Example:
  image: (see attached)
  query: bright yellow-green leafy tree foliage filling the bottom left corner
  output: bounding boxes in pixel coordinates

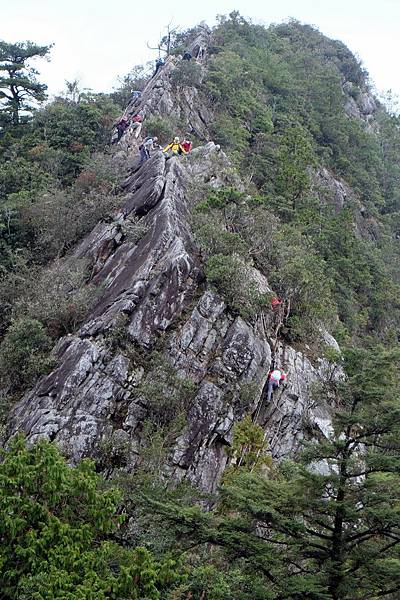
[0,437,184,600]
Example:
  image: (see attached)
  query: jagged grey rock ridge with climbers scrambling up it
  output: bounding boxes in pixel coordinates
[10,25,343,491]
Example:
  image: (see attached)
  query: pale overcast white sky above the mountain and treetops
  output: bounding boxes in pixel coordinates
[0,0,400,102]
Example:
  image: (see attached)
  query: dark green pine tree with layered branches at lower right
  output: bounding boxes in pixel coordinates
[222,349,400,600]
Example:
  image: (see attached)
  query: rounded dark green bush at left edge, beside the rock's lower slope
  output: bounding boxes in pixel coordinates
[0,317,53,391]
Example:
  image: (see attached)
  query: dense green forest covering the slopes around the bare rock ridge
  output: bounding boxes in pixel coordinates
[0,13,400,600]
